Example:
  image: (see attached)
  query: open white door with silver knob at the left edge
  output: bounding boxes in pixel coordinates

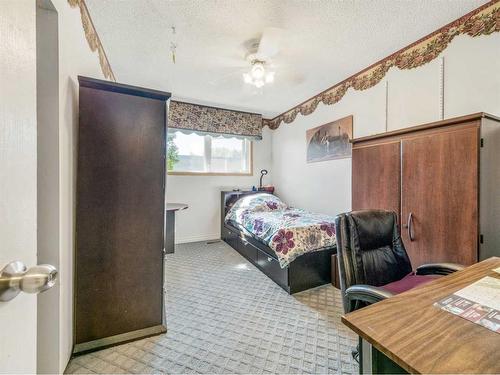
[0,0,57,373]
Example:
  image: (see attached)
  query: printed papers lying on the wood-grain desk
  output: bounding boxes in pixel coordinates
[434,276,500,333]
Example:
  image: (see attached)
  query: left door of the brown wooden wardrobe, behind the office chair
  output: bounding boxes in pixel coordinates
[352,141,401,215]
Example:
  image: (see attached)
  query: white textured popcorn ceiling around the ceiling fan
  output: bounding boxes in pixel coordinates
[86,0,486,117]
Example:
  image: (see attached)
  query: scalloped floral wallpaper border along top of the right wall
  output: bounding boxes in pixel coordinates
[262,0,500,130]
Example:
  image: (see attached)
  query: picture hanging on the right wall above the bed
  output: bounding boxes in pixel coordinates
[306,115,352,163]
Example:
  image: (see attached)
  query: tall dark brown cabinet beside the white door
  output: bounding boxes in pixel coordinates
[74,77,170,353]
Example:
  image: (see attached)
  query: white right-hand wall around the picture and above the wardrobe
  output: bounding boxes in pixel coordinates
[272,33,500,219]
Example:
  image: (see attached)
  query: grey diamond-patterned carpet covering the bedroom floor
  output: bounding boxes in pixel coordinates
[66,242,358,374]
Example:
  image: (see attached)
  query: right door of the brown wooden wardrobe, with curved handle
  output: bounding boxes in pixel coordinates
[401,123,479,267]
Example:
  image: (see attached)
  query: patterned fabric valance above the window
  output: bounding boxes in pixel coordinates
[168,100,262,139]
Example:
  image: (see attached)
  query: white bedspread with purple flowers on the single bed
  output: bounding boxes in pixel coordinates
[226,193,336,268]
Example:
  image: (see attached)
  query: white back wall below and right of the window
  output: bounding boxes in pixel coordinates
[167,128,274,243]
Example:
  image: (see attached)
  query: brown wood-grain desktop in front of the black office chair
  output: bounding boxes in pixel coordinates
[342,257,500,373]
